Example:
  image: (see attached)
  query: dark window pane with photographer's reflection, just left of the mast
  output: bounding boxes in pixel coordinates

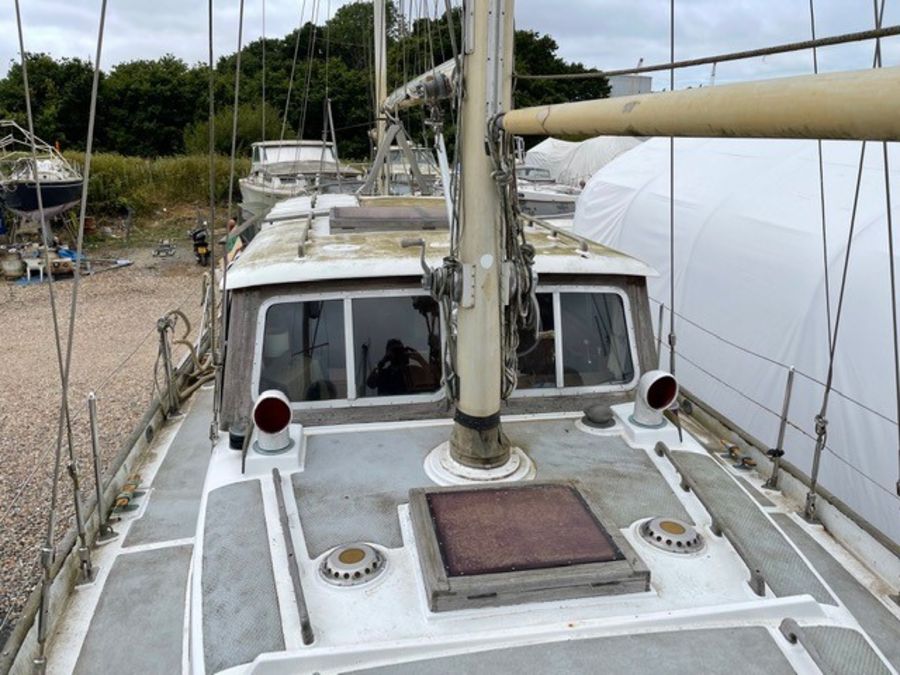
[353,296,441,398]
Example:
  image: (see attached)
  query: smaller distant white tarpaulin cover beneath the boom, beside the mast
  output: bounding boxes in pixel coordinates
[525,136,642,187]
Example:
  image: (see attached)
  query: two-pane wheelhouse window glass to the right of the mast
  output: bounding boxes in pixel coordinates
[518,291,635,390]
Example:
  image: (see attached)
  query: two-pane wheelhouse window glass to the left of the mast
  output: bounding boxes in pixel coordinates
[257,292,441,404]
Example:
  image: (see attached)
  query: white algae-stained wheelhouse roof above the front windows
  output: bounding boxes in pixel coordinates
[228,217,656,289]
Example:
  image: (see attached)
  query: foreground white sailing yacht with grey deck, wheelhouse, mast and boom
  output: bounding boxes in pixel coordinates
[3,0,900,674]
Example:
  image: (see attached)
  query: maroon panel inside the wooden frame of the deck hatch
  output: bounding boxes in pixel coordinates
[426,484,624,577]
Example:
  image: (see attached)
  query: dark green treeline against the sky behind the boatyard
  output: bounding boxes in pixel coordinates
[0,7,609,160]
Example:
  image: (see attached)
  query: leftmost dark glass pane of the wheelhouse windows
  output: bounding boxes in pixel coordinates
[259,300,347,401]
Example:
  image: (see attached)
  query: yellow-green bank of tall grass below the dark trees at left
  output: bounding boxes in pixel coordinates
[65,152,250,215]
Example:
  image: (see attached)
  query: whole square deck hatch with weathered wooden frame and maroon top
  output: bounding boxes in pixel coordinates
[409,482,650,612]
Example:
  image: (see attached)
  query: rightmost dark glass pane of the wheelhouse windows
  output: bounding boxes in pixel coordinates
[560,293,634,387]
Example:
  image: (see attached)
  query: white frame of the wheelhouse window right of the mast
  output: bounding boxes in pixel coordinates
[512,284,641,398]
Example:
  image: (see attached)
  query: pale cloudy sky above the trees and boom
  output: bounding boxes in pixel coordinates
[0,0,900,89]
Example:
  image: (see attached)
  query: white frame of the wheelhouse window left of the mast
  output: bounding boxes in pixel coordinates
[250,288,447,411]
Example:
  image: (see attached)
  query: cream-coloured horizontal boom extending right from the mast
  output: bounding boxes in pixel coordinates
[503,67,900,141]
